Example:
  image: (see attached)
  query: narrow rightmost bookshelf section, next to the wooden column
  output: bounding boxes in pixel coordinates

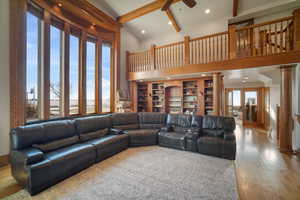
[204,80,213,115]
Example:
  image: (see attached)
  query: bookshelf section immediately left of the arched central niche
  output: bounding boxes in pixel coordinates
[152,83,165,112]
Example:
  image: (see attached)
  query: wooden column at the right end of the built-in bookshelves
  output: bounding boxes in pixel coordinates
[213,72,221,116]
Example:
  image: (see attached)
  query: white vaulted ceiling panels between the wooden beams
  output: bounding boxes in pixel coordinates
[89,0,298,40]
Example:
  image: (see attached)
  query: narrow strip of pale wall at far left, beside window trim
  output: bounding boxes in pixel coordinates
[0,0,10,156]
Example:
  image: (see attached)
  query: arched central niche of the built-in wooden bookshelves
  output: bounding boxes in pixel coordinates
[166,86,182,114]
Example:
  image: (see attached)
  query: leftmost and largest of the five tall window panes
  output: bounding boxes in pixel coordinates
[26,12,41,121]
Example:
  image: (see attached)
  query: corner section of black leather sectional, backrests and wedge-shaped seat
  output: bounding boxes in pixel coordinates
[112,113,166,147]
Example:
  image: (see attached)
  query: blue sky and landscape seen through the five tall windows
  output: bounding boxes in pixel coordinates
[26,12,111,116]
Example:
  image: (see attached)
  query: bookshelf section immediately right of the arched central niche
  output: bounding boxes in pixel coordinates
[182,81,199,114]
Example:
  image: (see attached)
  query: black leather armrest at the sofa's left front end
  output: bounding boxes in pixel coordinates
[11,147,44,166]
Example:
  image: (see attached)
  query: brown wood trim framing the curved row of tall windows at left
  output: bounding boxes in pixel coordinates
[10,0,120,128]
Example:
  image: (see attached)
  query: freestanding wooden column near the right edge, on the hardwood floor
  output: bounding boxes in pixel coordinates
[279,66,293,152]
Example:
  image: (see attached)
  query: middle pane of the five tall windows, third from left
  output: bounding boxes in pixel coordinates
[70,35,79,115]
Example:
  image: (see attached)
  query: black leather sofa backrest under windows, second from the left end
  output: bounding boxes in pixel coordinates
[75,115,112,141]
